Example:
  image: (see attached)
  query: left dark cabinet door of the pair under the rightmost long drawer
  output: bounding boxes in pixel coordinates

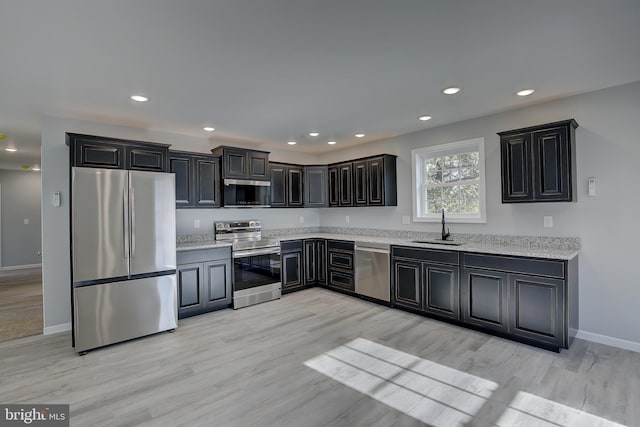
[460,268,509,332]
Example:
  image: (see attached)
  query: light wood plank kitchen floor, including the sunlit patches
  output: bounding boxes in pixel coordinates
[0,288,640,427]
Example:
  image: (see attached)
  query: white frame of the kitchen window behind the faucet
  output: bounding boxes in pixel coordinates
[411,137,487,223]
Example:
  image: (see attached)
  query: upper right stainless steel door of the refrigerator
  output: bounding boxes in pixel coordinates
[129,171,176,275]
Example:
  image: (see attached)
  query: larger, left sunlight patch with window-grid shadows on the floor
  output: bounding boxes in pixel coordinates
[305,338,498,427]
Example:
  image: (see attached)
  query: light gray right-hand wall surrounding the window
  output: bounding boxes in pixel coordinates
[320,82,640,348]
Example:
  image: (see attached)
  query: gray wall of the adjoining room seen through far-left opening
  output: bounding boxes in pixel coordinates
[0,169,42,268]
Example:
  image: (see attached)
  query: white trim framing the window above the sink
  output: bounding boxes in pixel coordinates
[411,137,487,223]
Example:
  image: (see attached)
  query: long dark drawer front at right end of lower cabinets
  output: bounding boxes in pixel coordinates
[463,253,565,279]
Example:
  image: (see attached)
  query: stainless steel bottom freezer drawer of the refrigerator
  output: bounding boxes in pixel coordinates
[73,274,178,352]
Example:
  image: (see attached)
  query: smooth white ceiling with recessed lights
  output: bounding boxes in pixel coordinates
[0,0,640,171]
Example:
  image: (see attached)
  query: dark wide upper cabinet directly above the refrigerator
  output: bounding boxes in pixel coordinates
[67,133,169,172]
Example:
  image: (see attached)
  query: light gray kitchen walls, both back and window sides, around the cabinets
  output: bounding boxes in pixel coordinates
[42,83,640,345]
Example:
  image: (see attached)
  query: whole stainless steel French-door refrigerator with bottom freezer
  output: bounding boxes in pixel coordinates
[71,167,178,353]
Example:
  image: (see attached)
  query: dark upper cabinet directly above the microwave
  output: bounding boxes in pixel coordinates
[211,146,269,181]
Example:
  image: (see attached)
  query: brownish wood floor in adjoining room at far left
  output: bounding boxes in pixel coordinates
[0,268,42,341]
